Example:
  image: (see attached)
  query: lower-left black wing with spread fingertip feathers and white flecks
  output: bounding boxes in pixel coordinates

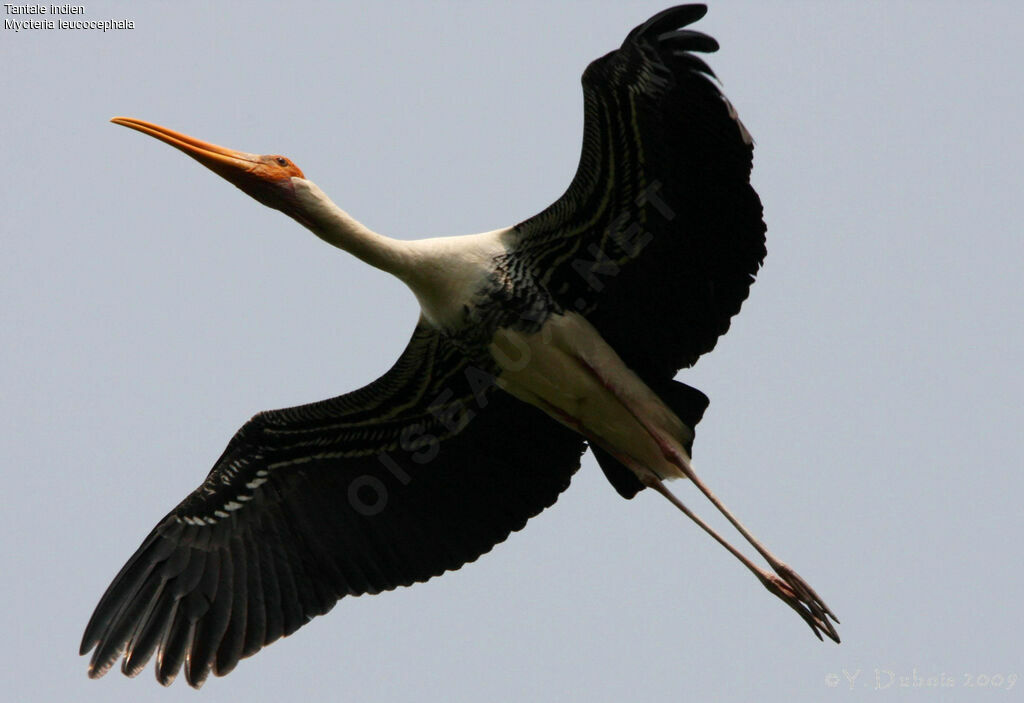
[81,325,584,687]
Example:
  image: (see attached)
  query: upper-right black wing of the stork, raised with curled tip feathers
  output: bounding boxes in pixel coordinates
[509,5,765,382]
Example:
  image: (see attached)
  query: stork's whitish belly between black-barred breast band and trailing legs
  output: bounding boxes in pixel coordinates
[490,312,693,479]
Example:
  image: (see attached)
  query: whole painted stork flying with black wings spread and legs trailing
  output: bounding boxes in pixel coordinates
[81,5,839,687]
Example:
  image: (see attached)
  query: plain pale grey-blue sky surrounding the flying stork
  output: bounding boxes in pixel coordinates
[0,0,1024,703]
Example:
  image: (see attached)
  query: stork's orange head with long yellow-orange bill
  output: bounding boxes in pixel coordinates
[111,118,305,222]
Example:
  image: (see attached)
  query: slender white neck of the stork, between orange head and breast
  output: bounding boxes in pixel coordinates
[292,178,415,279]
